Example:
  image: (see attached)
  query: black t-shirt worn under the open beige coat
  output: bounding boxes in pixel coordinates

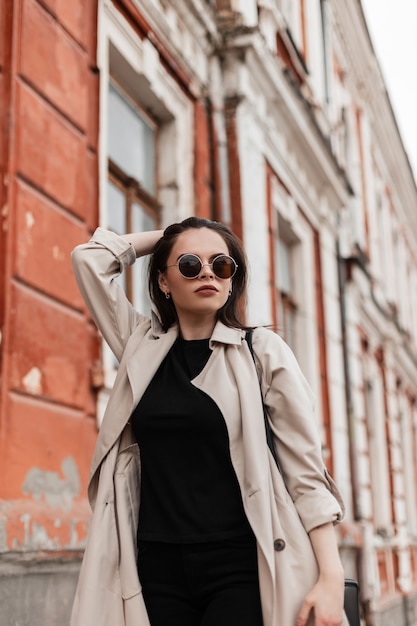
[132,338,250,543]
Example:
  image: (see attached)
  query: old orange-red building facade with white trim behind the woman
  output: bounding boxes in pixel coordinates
[0,0,417,626]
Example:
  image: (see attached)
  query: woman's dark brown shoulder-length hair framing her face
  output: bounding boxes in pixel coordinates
[148,217,247,329]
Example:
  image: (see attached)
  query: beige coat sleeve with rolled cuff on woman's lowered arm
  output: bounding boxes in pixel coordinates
[253,329,344,532]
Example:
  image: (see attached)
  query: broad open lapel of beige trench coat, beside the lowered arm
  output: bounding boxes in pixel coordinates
[192,325,275,581]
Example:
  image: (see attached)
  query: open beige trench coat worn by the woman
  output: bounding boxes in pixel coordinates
[71,228,343,626]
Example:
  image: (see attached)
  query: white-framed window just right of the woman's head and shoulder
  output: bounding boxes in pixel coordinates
[264,164,328,424]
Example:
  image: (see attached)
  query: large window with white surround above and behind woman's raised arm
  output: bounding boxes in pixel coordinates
[97,2,194,424]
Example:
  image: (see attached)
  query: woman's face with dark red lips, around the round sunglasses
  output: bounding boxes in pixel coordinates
[159,228,232,324]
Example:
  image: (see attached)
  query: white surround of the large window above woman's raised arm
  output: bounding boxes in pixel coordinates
[97,0,194,426]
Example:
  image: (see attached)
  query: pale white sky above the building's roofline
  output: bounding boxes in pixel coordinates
[362,0,417,180]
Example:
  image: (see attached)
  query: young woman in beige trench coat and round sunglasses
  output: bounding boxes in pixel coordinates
[72,217,347,626]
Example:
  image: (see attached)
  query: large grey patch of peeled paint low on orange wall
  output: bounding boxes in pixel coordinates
[22,457,80,511]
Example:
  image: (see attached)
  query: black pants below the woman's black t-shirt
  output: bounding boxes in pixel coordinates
[138,537,262,626]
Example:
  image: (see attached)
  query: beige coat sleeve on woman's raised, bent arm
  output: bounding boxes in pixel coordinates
[71,228,146,361]
